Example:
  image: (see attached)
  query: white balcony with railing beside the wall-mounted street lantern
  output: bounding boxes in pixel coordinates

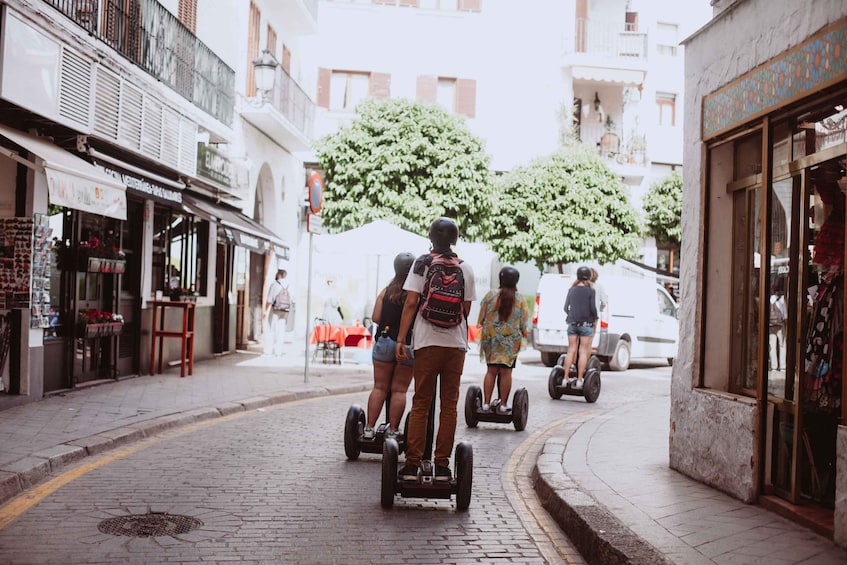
[239,66,315,151]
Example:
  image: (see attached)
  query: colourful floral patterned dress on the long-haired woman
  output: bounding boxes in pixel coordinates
[478,290,529,367]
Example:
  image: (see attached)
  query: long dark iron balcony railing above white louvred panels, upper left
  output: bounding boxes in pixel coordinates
[44,0,235,125]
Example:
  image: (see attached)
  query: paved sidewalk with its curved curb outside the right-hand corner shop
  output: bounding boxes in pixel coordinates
[536,396,847,565]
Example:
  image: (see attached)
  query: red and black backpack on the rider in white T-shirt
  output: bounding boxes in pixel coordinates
[419,253,465,328]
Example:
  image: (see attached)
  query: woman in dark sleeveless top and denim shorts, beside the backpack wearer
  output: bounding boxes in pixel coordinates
[362,253,415,439]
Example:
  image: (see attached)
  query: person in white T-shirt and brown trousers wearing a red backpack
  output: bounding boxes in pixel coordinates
[396,218,476,482]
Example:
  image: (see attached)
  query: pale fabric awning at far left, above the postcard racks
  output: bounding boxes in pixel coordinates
[0,125,126,220]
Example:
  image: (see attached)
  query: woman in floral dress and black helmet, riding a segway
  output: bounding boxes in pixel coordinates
[477,266,529,414]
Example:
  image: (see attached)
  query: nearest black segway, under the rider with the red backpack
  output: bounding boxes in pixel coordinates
[380,396,473,512]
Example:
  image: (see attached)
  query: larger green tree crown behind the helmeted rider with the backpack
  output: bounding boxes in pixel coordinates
[315,99,492,240]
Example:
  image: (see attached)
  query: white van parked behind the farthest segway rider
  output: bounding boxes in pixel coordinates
[532,273,679,371]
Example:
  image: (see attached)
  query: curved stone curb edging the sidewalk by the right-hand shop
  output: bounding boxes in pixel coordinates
[532,431,671,565]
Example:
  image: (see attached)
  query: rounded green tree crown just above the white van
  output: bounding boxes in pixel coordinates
[486,143,639,270]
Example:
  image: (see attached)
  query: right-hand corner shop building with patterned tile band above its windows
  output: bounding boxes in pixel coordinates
[670,0,847,545]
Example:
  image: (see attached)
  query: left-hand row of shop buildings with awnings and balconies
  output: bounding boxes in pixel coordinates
[0,0,317,405]
